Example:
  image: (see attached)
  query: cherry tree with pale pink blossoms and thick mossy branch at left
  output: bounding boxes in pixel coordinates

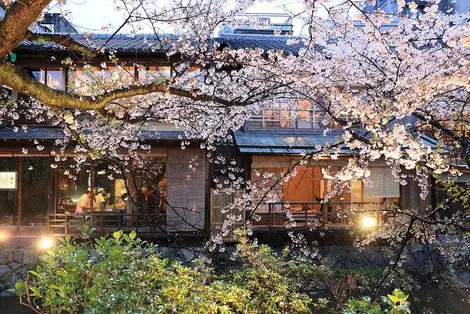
[0,0,470,288]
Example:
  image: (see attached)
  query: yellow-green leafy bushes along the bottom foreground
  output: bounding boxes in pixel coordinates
[15,227,408,314]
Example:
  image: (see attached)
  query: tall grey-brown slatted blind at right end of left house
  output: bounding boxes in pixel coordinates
[166,148,206,231]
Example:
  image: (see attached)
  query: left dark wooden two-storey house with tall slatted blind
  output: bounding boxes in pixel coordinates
[0,16,209,236]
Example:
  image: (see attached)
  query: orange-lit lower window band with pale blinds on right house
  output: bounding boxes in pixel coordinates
[251,156,400,223]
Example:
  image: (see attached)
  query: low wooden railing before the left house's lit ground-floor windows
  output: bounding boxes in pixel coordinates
[47,212,166,236]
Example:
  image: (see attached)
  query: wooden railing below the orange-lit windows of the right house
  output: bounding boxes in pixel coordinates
[252,202,391,228]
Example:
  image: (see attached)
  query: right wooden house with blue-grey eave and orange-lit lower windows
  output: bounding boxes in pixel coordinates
[234,110,436,229]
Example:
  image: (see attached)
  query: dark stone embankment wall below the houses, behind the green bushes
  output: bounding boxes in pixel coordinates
[0,244,470,296]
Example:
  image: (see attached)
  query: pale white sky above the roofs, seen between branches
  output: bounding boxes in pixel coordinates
[51,0,301,33]
